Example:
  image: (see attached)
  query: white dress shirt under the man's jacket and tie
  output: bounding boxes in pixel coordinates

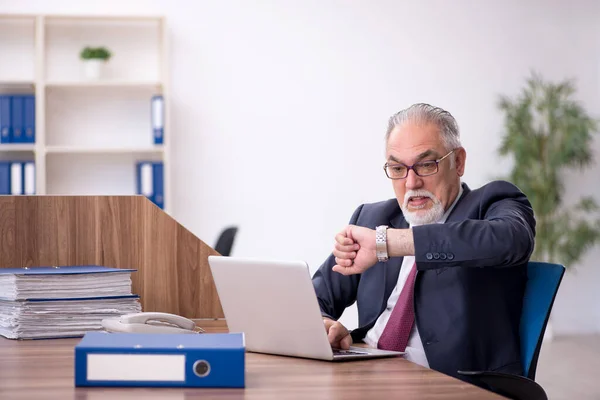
[363,185,463,368]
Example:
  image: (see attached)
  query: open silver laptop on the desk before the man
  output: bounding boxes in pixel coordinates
[208,256,404,361]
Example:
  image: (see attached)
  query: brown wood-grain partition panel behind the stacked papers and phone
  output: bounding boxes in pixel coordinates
[0,195,223,318]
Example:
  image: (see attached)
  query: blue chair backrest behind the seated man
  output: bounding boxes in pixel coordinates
[520,261,565,380]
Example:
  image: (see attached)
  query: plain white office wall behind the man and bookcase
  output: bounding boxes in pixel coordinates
[0,0,600,333]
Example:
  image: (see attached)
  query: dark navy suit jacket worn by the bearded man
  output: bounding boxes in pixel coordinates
[313,181,535,381]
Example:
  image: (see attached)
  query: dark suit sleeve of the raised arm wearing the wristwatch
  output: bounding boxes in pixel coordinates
[413,181,535,270]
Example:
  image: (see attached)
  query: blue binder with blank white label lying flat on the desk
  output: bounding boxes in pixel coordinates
[75,332,246,388]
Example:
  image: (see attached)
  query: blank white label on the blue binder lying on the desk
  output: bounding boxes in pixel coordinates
[87,354,185,382]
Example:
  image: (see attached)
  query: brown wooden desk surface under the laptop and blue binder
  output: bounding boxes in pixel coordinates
[0,320,501,400]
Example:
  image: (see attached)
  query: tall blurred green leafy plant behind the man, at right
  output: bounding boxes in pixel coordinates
[499,73,600,267]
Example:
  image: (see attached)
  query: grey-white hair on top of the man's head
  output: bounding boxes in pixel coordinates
[385,103,461,155]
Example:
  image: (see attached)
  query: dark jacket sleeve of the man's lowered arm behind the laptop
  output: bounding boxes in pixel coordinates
[312,205,363,320]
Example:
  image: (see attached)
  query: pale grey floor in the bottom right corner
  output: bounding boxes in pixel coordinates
[536,335,600,400]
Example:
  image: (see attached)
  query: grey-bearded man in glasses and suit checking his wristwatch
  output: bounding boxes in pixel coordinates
[313,104,535,379]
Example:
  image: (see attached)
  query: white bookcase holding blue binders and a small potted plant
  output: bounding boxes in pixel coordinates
[0,14,172,213]
